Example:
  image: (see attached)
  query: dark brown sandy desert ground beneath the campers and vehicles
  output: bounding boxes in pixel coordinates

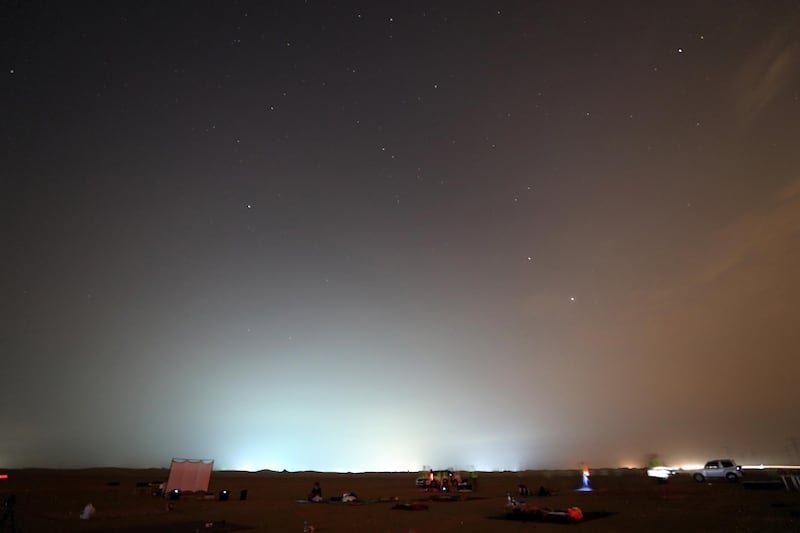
[0,469,800,533]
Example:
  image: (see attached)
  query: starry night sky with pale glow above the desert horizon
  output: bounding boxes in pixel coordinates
[0,0,800,471]
